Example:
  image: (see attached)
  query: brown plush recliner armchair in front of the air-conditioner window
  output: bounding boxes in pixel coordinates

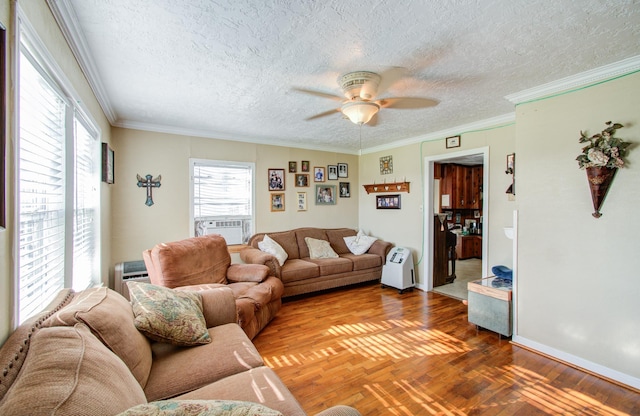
[142,234,284,339]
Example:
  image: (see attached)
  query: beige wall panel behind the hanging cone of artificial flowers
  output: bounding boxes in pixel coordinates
[516,73,640,387]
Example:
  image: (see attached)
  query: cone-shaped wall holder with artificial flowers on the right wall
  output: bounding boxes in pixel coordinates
[576,121,631,218]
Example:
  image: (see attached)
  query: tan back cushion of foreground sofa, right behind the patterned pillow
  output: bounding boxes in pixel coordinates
[42,287,152,387]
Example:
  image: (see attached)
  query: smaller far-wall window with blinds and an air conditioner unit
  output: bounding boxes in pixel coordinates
[189,159,254,245]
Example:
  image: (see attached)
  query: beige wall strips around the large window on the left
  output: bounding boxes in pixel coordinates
[0,1,111,342]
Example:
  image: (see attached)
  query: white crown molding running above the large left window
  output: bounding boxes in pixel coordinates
[47,0,118,125]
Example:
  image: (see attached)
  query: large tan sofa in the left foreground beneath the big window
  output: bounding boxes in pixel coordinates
[0,287,359,416]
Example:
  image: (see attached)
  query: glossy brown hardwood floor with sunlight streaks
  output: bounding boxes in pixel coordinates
[253,284,640,416]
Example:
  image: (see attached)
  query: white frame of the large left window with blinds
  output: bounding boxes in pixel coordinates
[11,3,102,328]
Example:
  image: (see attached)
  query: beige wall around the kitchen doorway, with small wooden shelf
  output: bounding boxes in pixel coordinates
[360,125,515,288]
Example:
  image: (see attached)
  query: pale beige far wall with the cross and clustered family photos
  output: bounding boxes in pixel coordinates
[111,128,359,269]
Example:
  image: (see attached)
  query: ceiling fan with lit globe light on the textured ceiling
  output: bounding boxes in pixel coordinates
[294,67,438,125]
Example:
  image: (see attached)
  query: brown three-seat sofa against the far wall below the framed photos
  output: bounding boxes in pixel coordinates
[240,227,392,297]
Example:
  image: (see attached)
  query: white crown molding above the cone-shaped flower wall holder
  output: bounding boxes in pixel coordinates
[504,55,640,105]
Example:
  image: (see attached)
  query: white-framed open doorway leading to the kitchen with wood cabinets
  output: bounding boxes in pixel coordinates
[423,147,489,299]
